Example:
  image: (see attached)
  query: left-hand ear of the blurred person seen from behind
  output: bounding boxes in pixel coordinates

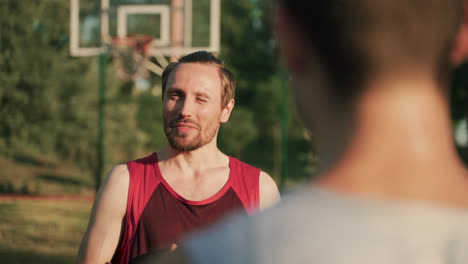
[274,3,309,74]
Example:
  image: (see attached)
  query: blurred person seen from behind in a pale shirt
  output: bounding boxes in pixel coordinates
[137,0,468,264]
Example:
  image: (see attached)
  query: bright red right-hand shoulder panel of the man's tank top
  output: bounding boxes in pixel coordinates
[229,157,260,214]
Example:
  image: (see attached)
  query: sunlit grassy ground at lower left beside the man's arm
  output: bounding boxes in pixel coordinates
[0,154,93,264]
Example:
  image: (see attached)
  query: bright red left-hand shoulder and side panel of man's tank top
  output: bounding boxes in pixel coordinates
[112,153,160,264]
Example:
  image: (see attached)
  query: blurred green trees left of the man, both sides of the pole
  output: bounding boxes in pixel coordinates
[0,0,142,179]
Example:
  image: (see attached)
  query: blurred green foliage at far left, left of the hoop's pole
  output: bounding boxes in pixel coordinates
[0,1,92,159]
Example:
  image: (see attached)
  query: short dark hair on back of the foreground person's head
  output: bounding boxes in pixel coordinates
[280,0,463,100]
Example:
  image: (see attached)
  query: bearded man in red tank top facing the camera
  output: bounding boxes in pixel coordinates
[78,51,279,264]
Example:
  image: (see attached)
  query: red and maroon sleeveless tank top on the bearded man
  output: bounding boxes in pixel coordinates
[112,153,260,264]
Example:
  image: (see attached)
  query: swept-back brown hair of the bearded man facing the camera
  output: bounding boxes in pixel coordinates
[162,51,236,107]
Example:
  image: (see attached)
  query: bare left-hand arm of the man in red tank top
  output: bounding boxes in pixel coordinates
[77,165,129,264]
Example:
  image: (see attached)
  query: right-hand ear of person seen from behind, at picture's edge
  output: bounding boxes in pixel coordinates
[450,0,468,66]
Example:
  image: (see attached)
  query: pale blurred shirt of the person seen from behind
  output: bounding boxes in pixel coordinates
[185,187,468,264]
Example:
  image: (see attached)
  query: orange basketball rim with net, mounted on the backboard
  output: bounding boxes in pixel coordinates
[111,35,153,81]
